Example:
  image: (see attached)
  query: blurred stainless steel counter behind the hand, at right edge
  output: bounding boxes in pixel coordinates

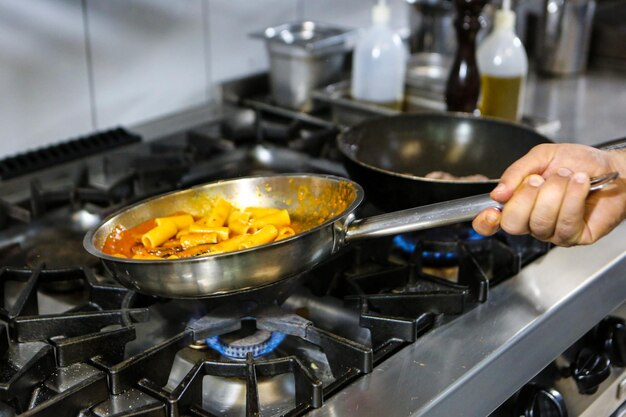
[525,70,626,145]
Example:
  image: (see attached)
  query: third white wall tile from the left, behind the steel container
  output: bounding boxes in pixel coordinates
[208,0,299,83]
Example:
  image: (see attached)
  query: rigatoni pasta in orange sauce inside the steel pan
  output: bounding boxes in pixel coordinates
[103,198,297,260]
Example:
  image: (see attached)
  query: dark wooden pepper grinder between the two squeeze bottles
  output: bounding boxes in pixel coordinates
[446,0,488,113]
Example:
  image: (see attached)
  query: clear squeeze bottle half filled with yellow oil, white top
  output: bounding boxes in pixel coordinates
[477,0,528,121]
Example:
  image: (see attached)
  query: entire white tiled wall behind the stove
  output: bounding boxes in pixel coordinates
[0,0,408,158]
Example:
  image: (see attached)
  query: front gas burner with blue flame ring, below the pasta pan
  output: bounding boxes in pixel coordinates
[206,330,286,359]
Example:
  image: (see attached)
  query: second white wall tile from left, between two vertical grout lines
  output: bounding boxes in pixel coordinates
[87,0,209,128]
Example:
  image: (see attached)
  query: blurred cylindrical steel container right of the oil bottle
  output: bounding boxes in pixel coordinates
[537,0,596,75]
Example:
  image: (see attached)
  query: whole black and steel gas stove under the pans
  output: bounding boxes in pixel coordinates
[0,106,626,417]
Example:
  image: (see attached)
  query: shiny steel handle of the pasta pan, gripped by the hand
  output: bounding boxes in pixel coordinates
[344,172,619,242]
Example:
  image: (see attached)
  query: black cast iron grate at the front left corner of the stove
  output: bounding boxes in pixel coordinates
[0,265,147,416]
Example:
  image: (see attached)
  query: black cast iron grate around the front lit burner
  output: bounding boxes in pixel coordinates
[83,303,372,416]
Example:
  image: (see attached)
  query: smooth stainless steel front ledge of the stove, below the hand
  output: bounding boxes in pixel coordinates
[311,223,626,417]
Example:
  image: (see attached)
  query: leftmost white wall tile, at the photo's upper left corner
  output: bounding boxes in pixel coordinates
[0,0,93,158]
